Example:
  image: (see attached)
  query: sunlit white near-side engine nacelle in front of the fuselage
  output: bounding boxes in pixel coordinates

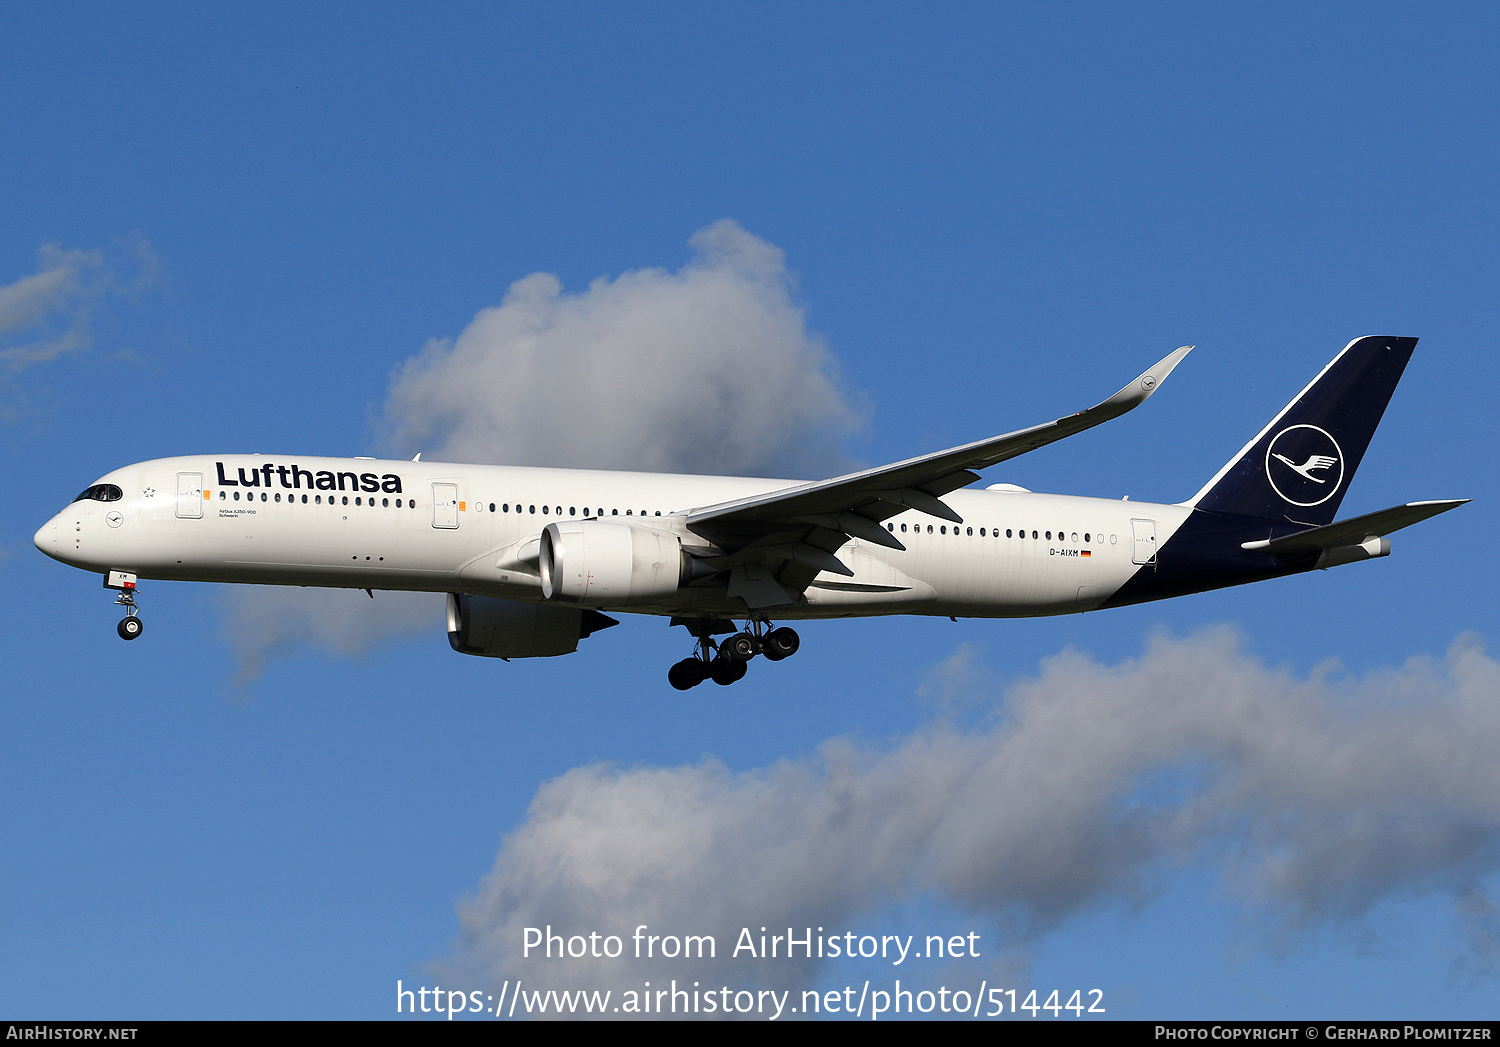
[537,521,693,608]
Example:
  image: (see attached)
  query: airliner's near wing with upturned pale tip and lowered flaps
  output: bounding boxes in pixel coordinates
[687,345,1193,609]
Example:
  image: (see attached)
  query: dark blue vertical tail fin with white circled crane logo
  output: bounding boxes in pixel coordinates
[1187,338,1416,527]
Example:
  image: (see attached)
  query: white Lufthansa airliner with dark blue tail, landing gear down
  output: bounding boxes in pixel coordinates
[36,338,1467,690]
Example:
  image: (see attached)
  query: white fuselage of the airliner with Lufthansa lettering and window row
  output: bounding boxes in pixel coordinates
[36,455,1193,618]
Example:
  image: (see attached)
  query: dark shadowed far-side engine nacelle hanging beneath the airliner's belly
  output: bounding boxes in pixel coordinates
[449,593,620,659]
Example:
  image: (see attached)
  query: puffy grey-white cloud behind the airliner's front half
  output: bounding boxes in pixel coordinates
[228,221,857,680]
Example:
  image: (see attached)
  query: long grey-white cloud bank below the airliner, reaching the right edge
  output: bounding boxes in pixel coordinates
[453,630,1500,989]
